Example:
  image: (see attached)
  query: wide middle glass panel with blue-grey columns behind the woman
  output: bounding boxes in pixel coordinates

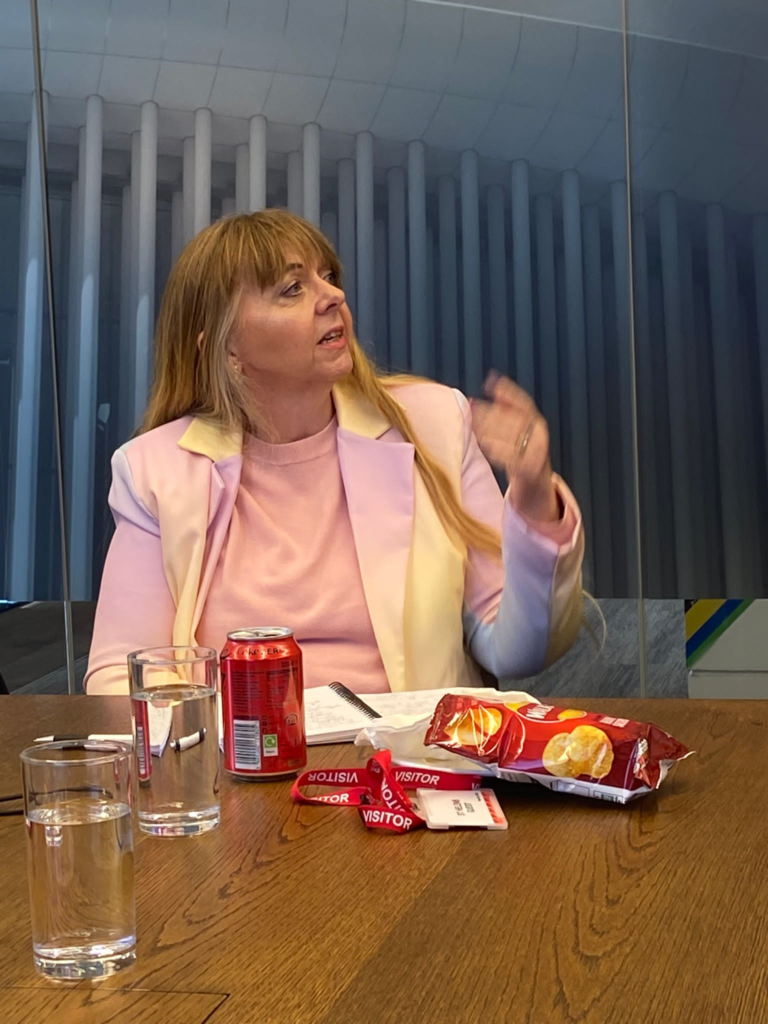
[34,0,639,694]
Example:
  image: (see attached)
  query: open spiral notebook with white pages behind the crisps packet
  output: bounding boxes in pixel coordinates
[304,683,479,744]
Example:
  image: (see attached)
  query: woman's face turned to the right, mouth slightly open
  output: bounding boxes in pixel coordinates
[229,254,352,387]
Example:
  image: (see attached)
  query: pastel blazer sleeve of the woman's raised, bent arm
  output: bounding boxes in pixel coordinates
[457,392,584,679]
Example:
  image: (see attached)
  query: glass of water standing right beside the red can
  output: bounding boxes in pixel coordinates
[128,646,220,836]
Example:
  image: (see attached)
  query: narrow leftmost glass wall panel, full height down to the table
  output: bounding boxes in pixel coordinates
[0,0,68,693]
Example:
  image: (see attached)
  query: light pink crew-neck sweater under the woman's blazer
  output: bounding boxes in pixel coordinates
[198,419,389,693]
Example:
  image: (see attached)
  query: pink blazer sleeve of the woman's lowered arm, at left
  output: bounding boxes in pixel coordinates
[85,446,176,694]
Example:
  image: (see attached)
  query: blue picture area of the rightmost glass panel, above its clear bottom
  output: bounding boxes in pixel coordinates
[629,6,768,598]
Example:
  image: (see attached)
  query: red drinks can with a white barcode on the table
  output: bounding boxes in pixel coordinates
[220,626,306,779]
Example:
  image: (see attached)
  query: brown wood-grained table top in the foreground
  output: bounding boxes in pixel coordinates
[0,696,768,1024]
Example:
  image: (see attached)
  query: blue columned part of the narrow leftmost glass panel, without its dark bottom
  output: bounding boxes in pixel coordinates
[0,4,62,601]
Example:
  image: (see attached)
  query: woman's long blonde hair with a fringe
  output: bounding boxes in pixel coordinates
[140,210,501,557]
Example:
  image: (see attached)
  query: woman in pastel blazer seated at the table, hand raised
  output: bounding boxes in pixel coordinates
[86,210,584,693]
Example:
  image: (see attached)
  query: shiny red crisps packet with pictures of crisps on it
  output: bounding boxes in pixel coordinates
[424,693,691,804]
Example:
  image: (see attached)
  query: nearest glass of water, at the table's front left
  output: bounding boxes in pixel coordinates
[20,740,136,979]
